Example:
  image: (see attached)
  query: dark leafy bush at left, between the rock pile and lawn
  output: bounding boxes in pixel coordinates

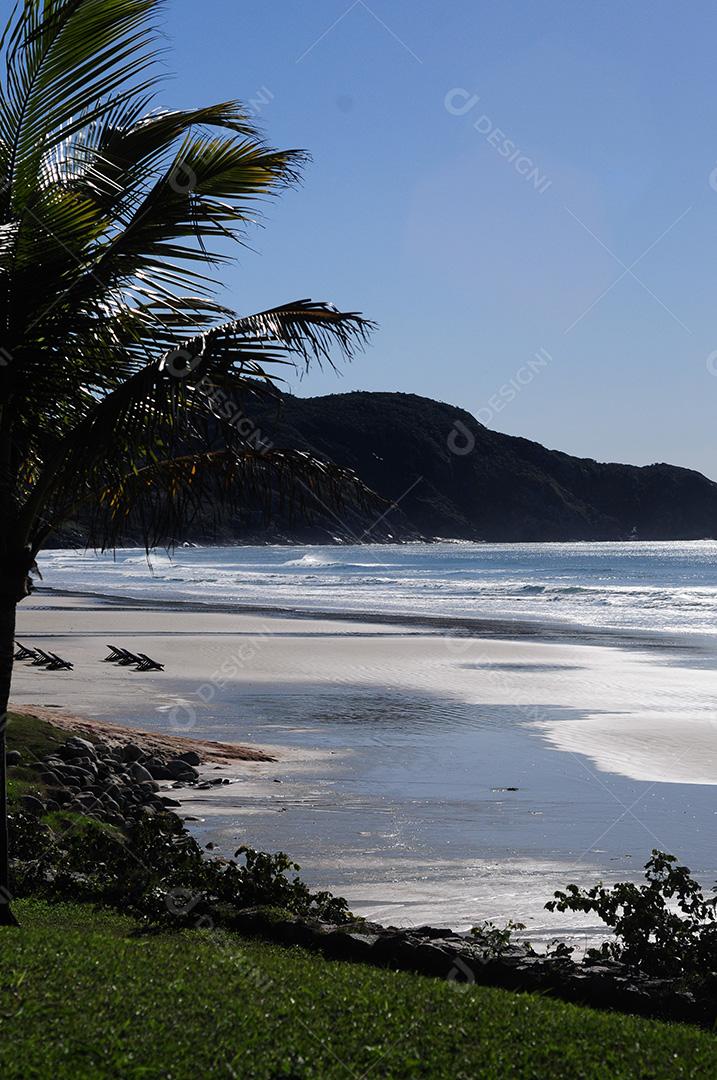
[11,811,351,927]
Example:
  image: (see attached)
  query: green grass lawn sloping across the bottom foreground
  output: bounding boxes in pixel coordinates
[0,901,717,1080]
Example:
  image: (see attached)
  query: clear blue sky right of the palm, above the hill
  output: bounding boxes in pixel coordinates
[168,0,717,478]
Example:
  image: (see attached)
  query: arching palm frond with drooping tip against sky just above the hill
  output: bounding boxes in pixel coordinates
[18,300,373,545]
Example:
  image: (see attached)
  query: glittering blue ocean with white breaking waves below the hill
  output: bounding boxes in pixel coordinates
[40,540,717,635]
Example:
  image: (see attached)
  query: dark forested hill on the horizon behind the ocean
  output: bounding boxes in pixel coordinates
[213,392,717,541]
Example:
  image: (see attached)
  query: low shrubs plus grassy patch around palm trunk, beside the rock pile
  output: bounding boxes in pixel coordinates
[8,713,353,929]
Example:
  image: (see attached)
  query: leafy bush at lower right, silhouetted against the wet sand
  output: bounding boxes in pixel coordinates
[545,850,717,986]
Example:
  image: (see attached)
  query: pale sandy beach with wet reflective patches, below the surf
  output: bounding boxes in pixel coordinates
[13,591,717,940]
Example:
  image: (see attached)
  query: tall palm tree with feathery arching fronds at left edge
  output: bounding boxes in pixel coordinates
[0,0,371,922]
